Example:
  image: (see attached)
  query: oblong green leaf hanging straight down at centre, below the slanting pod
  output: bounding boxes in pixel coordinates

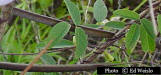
[75,27,88,58]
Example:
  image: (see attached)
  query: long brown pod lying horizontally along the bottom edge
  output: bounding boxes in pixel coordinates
[0,62,140,72]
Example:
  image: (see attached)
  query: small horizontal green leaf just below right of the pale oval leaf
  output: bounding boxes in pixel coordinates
[105,21,125,29]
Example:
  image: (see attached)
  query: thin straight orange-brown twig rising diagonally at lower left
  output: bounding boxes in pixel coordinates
[20,40,53,75]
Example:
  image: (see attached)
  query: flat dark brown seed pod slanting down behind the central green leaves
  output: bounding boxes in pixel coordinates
[12,8,114,38]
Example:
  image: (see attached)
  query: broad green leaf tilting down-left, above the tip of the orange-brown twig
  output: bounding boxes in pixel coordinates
[38,22,71,48]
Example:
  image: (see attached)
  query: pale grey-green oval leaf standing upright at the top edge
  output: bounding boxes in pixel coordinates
[93,0,108,22]
